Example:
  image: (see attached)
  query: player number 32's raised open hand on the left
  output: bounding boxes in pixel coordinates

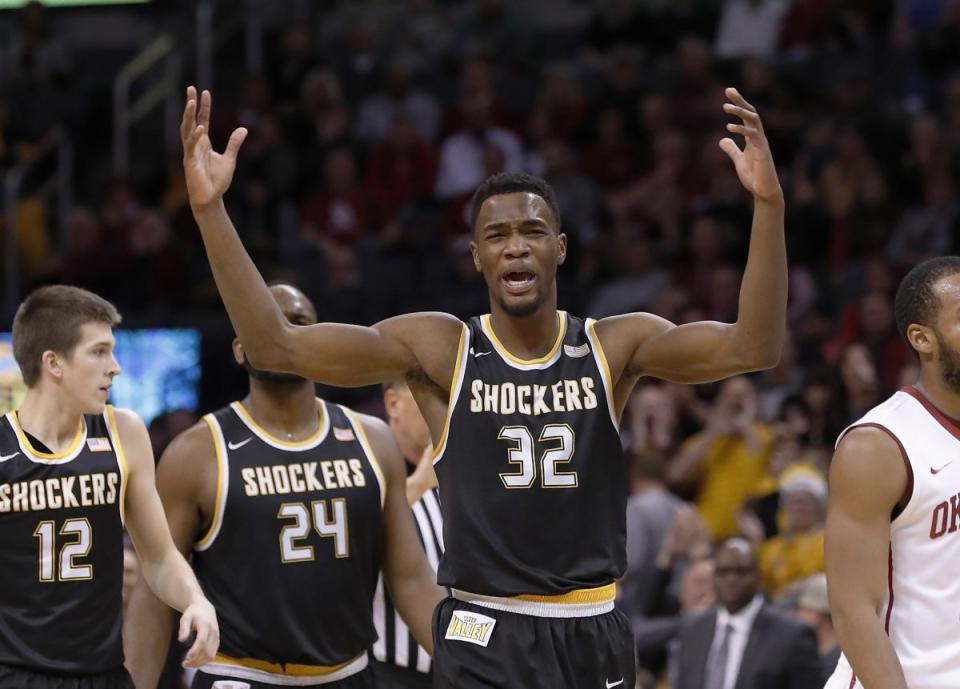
[180,86,247,209]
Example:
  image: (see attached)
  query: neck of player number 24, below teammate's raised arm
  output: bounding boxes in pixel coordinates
[243,380,320,440]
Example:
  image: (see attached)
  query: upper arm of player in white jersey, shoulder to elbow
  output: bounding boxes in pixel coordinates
[826,427,907,615]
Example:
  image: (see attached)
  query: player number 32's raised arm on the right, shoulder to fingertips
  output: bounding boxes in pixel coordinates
[597,88,787,383]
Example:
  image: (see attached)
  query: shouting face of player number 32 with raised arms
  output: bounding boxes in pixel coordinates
[470,192,567,317]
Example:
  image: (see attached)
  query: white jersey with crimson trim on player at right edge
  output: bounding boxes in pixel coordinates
[826,387,960,689]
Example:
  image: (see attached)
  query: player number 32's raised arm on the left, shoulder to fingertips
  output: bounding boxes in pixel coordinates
[180,86,460,387]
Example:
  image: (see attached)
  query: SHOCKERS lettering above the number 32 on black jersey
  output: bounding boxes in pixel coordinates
[470,376,597,416]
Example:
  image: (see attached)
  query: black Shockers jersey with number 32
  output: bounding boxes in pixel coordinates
[436,311,627,596]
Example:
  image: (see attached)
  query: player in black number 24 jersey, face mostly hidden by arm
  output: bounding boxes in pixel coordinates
[127,284,446,689]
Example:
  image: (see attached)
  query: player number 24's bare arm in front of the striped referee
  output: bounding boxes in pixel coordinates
[361,416,446,655]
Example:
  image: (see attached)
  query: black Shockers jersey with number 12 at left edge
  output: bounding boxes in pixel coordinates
[0,406,127,675]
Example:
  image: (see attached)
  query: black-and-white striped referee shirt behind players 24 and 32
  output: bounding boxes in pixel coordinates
[373,488,443,673]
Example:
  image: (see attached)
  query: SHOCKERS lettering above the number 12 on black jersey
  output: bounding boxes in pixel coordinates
[0,471,120,513]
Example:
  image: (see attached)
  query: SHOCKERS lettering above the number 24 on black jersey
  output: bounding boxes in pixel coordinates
[240,459,367,497]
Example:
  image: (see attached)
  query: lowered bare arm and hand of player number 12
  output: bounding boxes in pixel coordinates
[116,409,220,667]
